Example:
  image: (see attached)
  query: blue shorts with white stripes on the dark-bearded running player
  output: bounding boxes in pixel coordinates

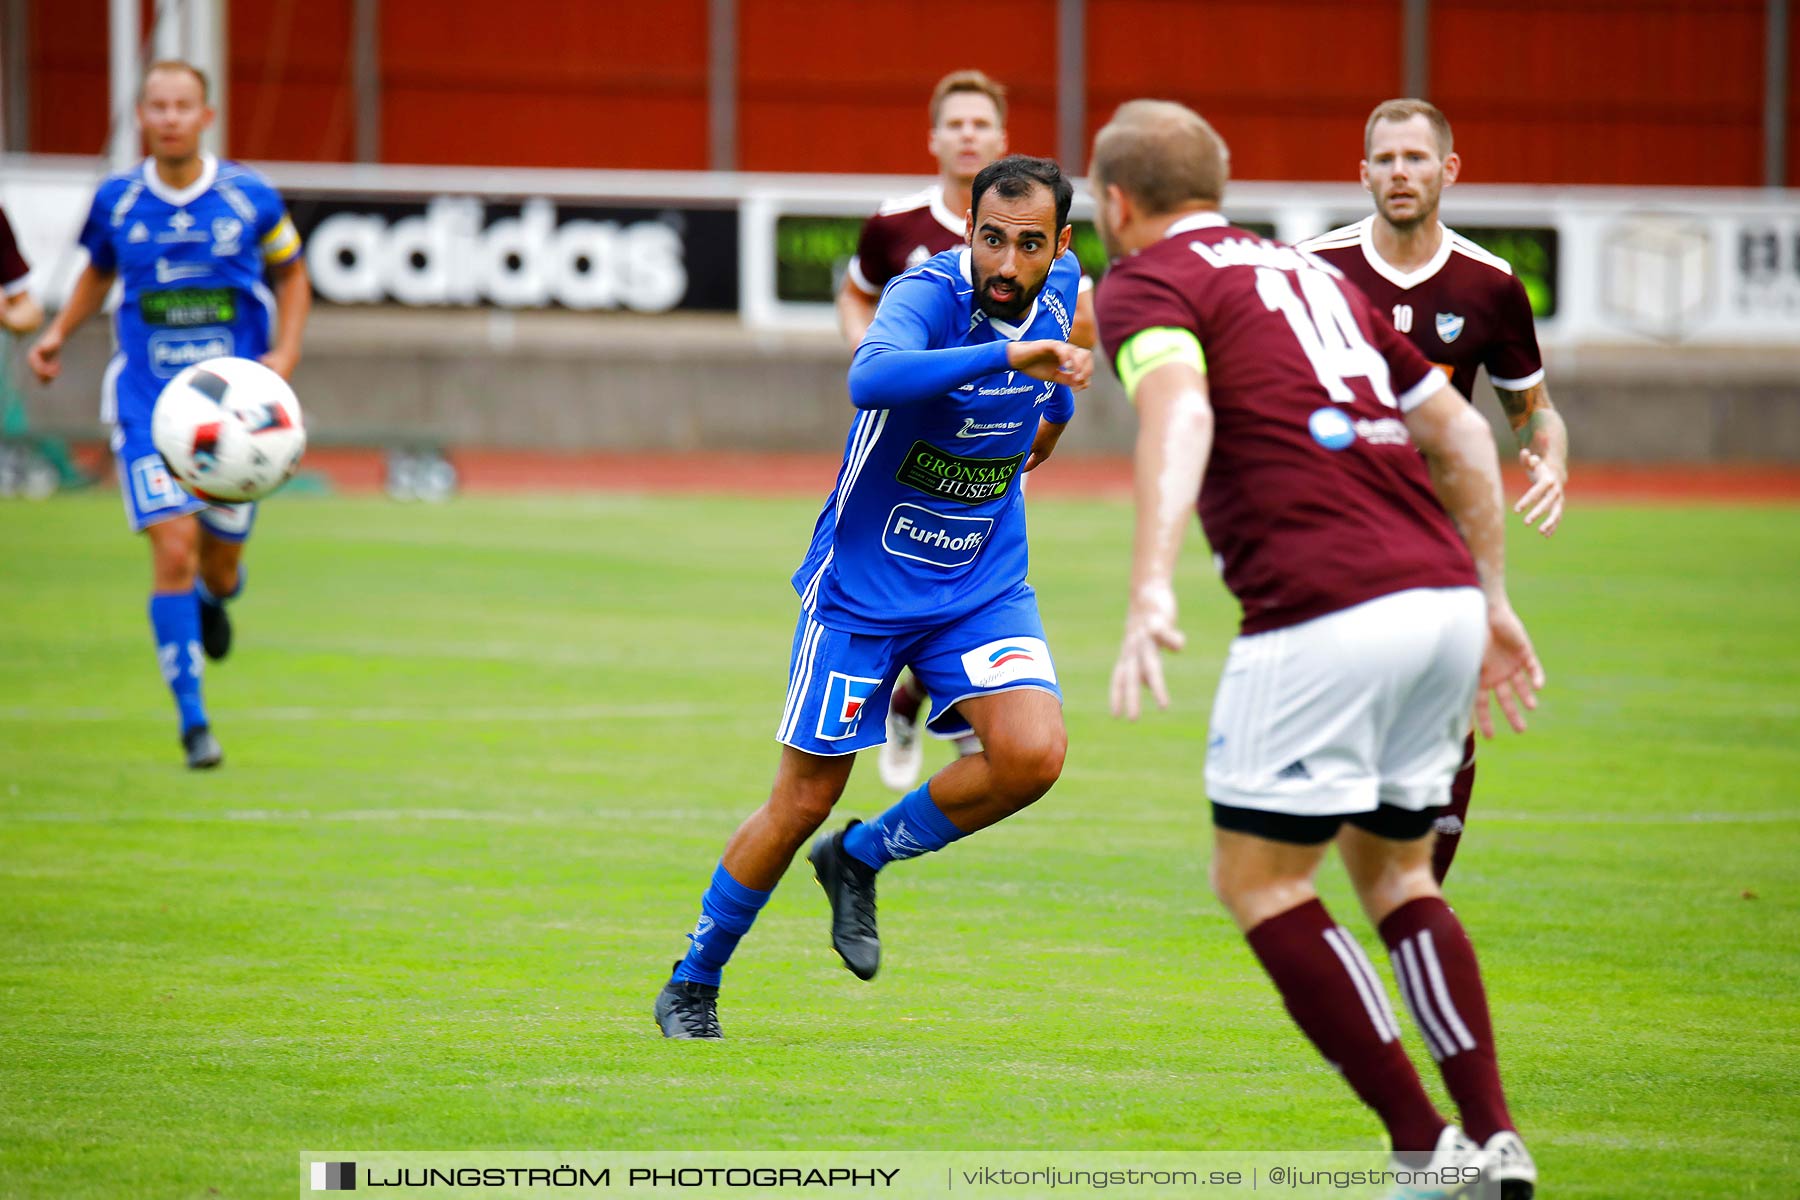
[776,583,1062,754]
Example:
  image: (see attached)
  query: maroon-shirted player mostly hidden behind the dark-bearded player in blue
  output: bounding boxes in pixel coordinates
[837,70,1094,792]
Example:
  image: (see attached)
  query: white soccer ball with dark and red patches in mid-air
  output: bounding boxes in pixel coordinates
[149,358,306,504]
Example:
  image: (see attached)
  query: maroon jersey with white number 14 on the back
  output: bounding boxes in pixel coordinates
[1096,212,1476,633]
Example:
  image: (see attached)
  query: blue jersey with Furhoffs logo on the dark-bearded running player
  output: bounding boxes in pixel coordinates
[794,248,1082,633]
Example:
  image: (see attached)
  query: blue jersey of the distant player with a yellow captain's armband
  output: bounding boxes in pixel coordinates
[81,155,301,423]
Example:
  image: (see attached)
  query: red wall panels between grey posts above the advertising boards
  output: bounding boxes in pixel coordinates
[29,0,1800,187]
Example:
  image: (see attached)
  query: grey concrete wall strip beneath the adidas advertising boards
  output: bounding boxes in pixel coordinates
[14,309,1800,464]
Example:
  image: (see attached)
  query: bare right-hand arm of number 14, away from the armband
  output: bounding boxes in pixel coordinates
[1406,387,1544,738]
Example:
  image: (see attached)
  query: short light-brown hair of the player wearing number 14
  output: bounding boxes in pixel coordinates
[1089,101,1231,212]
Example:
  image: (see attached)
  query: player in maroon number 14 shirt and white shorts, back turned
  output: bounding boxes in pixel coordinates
[1091,101,1543,1200]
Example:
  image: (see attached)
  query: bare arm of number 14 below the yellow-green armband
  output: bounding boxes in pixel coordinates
[1112,362,1213,721]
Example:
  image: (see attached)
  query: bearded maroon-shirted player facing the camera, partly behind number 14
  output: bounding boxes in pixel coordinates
[1300,99,1570,883]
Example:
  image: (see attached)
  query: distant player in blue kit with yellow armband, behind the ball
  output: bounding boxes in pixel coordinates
[31,61,311,768]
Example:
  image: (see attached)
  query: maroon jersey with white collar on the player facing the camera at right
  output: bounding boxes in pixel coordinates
[1300,216,1544,398]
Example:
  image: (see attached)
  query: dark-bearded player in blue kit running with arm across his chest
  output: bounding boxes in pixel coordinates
[655,155,1093,1038]
